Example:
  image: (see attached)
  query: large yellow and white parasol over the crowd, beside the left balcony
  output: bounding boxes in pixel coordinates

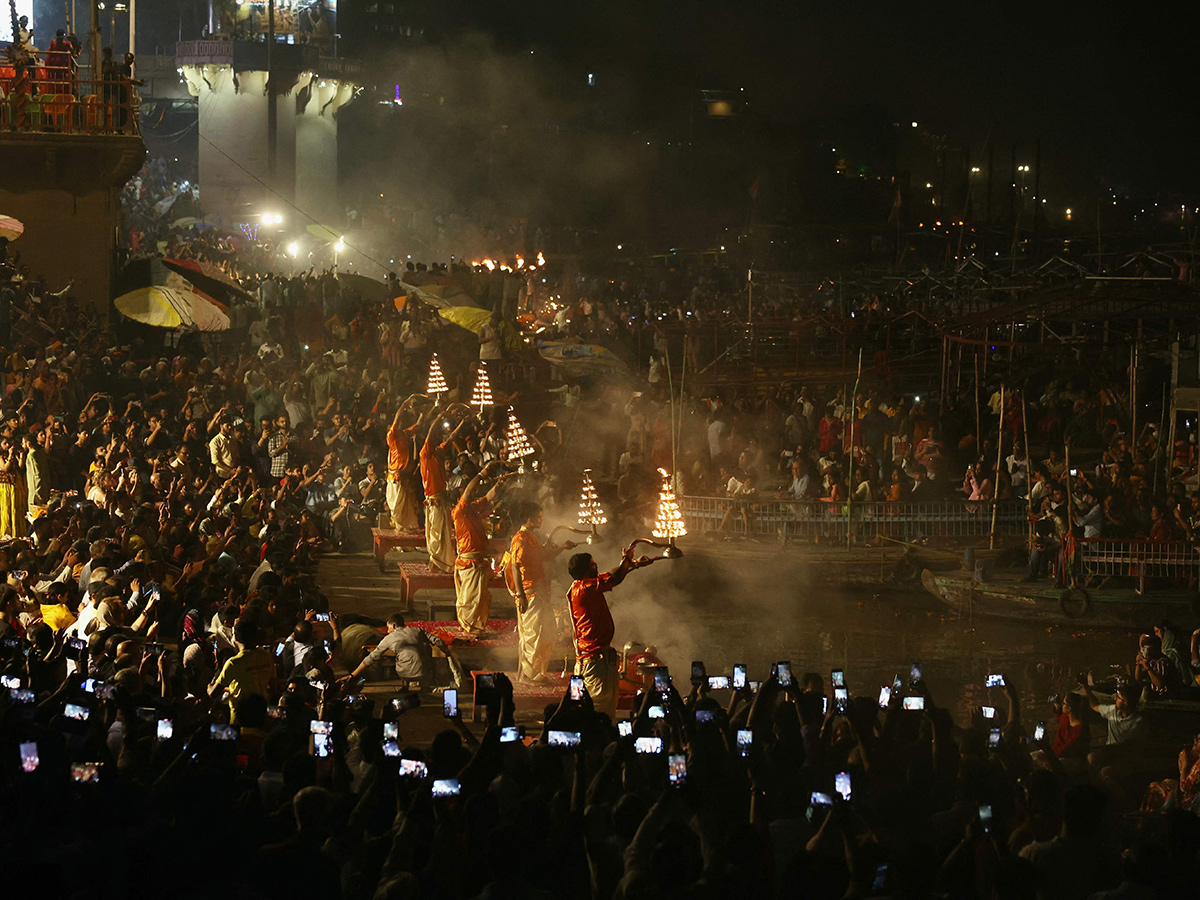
[113,259,229,331]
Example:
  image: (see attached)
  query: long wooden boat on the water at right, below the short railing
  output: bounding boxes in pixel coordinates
[920,569,1198,631]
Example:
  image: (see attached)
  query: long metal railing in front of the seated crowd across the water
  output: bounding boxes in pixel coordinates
[679,494,1028,541]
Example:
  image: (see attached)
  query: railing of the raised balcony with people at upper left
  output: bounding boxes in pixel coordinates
[0,66,138,134]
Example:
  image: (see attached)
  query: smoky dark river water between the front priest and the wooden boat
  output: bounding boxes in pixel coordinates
[610,554,1150,724]
